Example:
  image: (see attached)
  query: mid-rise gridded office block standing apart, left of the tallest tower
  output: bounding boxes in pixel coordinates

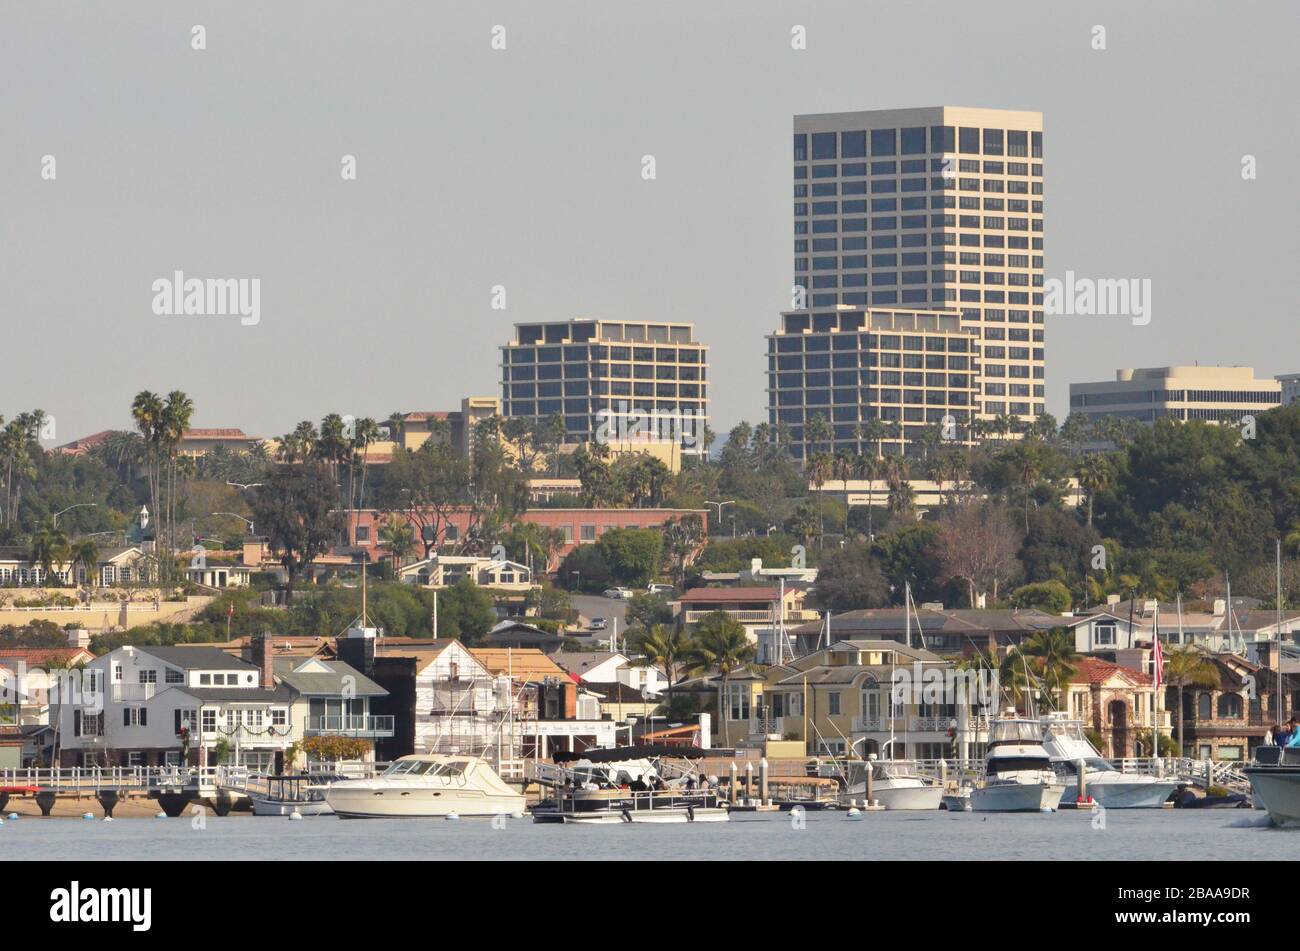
[501,320,709,459]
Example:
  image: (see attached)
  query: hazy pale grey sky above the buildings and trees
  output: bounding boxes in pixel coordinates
[0,0,1300,442]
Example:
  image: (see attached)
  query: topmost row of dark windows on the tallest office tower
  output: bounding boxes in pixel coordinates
[794,126,1043,162]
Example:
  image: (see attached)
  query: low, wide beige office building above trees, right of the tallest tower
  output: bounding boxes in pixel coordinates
[1070,366,1282,424]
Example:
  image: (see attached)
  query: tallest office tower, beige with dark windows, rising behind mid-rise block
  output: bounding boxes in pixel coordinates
[770,107,1044,457]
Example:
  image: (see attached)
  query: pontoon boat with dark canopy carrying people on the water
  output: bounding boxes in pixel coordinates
[533,747,729,825]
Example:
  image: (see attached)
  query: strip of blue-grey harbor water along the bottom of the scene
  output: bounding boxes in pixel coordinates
[0,809,1300,861]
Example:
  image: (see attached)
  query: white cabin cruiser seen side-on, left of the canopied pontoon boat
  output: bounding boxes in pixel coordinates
[325,754,524,818]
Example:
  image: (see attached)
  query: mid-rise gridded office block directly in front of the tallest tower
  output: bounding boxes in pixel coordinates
[767,304,980,456]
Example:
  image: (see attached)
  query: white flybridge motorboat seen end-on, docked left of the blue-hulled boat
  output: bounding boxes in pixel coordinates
[971,718,1065,812]
